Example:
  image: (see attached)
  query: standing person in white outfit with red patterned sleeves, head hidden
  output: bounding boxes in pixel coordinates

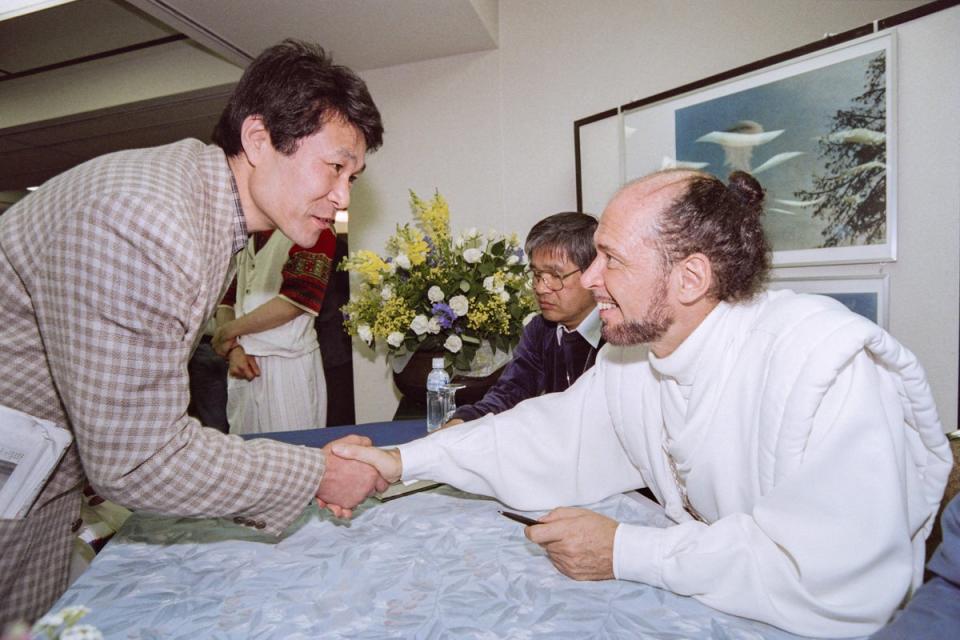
[212,229,336,434]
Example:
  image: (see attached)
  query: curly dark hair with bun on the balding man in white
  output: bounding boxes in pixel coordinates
[657,171,770,302]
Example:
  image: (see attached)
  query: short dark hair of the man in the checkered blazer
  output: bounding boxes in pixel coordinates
[213,39,383,156]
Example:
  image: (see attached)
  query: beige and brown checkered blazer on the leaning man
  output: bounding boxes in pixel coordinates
[0,140,324,627]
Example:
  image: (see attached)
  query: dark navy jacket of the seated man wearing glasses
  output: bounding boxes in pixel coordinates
[453,315,602,421]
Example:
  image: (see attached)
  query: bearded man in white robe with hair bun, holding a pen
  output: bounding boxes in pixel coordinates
[334,171,951,637]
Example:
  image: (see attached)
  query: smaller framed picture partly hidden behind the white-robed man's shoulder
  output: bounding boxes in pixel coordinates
[769,274,890,329]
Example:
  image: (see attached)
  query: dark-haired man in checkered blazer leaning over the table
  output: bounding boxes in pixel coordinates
[0,40,386,628]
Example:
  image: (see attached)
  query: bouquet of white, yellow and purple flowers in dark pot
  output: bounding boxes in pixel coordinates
[341,191,537,371]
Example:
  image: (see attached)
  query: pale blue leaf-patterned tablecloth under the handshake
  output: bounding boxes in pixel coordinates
[52,487,848,640]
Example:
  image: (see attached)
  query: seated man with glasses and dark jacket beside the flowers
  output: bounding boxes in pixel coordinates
[446,212,602,426]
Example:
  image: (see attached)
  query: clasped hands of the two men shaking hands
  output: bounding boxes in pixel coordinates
[317,435,403,518]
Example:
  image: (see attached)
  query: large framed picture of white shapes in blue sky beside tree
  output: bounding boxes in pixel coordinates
[621,31,897,266]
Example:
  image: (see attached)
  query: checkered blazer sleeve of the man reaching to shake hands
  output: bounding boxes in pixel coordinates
[34,195,324,534]
